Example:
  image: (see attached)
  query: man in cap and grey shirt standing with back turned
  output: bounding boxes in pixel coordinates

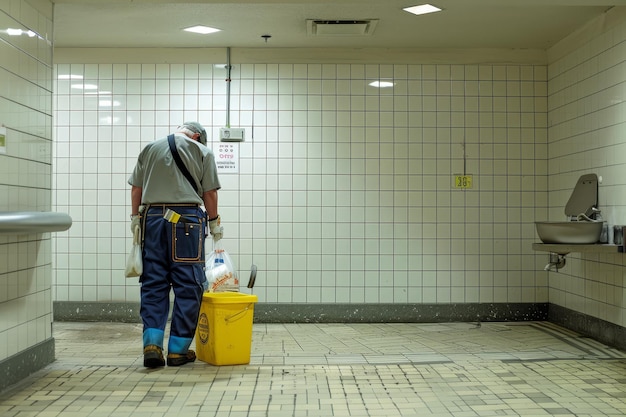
[128,122,223,368]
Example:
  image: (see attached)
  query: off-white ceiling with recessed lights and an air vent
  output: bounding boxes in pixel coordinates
[53,0,626,50]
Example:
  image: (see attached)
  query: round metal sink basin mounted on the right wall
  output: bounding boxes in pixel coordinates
[535,221,604,245]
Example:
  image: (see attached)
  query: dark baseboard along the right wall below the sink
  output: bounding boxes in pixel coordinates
[548,304,626,351]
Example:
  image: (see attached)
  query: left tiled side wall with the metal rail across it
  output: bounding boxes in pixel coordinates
[0,0,54,389]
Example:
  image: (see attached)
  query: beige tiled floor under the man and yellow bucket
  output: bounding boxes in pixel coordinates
[0,322,626,417]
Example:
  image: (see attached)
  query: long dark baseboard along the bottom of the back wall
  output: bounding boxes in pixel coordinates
[54,301,548,323]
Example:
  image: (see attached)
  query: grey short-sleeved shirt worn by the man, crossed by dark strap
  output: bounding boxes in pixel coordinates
[128,134,221,205]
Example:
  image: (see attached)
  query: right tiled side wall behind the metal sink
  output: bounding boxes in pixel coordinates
[548,8,626,327]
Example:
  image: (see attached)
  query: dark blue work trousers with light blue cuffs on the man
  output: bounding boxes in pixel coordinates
[140,204,207,354]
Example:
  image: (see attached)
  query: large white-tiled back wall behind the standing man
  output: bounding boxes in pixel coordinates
[54,55,548,304]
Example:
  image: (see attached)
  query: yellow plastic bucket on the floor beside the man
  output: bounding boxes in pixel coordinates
[196,292,258,365]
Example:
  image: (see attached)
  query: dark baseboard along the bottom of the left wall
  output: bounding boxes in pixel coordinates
[0,338,54,391]
